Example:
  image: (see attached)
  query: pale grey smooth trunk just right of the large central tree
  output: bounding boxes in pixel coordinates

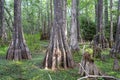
[70,0,79,51]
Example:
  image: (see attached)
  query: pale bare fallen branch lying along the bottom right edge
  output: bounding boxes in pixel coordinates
[77,75,120,80]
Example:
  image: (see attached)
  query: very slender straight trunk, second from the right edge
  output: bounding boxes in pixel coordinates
[110,0,114,47]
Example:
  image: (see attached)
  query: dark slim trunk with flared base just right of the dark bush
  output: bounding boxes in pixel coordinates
[97,0,108,48]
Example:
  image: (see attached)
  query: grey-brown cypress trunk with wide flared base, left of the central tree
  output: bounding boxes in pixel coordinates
[6,0,31,60]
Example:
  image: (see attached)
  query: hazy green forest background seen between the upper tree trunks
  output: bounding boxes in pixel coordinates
[0,0,118,41]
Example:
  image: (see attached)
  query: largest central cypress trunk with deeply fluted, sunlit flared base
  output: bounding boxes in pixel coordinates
[43,0,74,70]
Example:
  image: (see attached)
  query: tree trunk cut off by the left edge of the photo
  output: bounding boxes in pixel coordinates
[0,0,7,41]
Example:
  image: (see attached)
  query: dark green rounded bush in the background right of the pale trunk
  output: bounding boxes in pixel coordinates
[80,16,96,40]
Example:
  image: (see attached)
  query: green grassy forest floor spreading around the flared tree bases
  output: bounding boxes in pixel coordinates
[0,34,120,80]
